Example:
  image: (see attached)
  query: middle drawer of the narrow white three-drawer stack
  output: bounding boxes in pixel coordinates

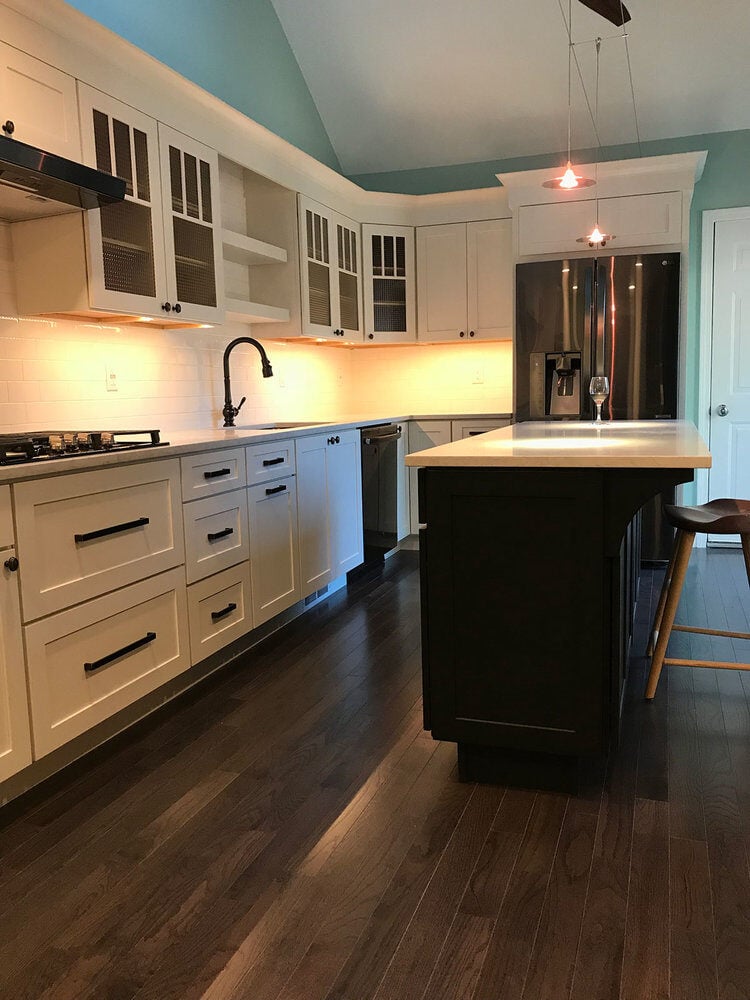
[183,490,249,583]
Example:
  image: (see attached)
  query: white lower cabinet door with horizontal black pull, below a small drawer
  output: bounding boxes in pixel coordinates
[247,476,301,626]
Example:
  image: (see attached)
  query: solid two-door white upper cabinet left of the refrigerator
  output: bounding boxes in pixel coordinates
[417,219,513,341]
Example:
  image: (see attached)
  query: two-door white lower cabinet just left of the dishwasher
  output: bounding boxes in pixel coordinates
[297,430,364,597]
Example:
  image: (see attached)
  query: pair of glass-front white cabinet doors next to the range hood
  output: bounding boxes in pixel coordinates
[79,84,223,323]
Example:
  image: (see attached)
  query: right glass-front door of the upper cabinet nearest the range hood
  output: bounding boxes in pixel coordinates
[159,123,223,323]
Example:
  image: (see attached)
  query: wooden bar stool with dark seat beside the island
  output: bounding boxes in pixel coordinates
[646,499,750,699]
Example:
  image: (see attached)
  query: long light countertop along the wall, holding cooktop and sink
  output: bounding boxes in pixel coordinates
[0,413,511,483]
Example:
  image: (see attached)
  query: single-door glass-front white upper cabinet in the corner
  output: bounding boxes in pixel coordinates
[362,225,417,344]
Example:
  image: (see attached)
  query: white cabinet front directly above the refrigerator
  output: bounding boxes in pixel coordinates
[518,191,682,257]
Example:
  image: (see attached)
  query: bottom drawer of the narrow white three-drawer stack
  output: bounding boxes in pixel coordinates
[188,563,253,663]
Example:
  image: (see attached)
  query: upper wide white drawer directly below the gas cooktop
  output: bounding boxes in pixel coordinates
[13,459,184,621]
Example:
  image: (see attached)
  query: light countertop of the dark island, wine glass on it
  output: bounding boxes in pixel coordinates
[406,420,711,469]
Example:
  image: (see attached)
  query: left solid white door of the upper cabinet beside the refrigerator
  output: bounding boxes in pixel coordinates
[417,222,468,341]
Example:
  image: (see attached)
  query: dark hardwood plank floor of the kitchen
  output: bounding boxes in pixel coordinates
[0,550,750,1000]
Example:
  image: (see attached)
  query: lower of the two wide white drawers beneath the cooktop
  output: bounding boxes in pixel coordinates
[24,568,190,758]
